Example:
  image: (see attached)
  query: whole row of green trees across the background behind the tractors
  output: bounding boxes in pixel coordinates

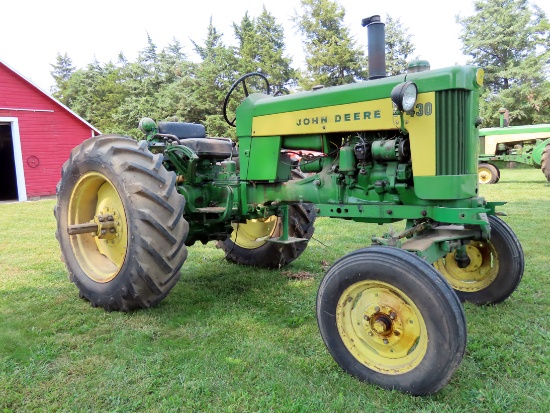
[50,0,550,137]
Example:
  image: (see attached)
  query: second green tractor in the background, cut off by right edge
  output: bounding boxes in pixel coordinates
[478,108,550,184]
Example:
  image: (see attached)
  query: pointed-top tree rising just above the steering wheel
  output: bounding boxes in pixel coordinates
[233,6,297,92]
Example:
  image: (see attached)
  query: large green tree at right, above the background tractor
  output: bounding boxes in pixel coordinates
[456,0,550,126]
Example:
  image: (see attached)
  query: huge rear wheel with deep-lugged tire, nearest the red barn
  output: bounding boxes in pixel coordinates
[54,135,189,311]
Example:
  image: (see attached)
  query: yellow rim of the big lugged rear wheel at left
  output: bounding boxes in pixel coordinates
[68,172,128,283]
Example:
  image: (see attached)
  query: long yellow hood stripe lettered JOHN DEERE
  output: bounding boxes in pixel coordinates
[252,99,396,136]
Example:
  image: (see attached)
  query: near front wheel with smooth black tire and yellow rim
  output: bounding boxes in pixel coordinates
[317,246,466,395]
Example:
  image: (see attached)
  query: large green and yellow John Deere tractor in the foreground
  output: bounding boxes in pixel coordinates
[55,16,524,395]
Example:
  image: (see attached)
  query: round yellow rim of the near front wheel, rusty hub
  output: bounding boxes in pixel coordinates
[336,281,428,374]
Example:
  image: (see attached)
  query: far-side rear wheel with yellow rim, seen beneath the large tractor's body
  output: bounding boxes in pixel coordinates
[217,203,315,268]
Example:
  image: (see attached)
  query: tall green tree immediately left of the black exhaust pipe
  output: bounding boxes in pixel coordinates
[293,0,367,89]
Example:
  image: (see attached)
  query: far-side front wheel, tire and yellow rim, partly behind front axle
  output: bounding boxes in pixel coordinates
[434,215,525,305]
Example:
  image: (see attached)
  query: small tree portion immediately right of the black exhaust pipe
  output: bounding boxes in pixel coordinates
[386,14,415,76]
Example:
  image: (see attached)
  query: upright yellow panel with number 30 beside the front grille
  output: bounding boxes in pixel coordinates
[403,92,437,176]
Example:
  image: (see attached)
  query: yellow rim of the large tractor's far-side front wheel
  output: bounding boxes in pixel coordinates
[434,241,499,292]
